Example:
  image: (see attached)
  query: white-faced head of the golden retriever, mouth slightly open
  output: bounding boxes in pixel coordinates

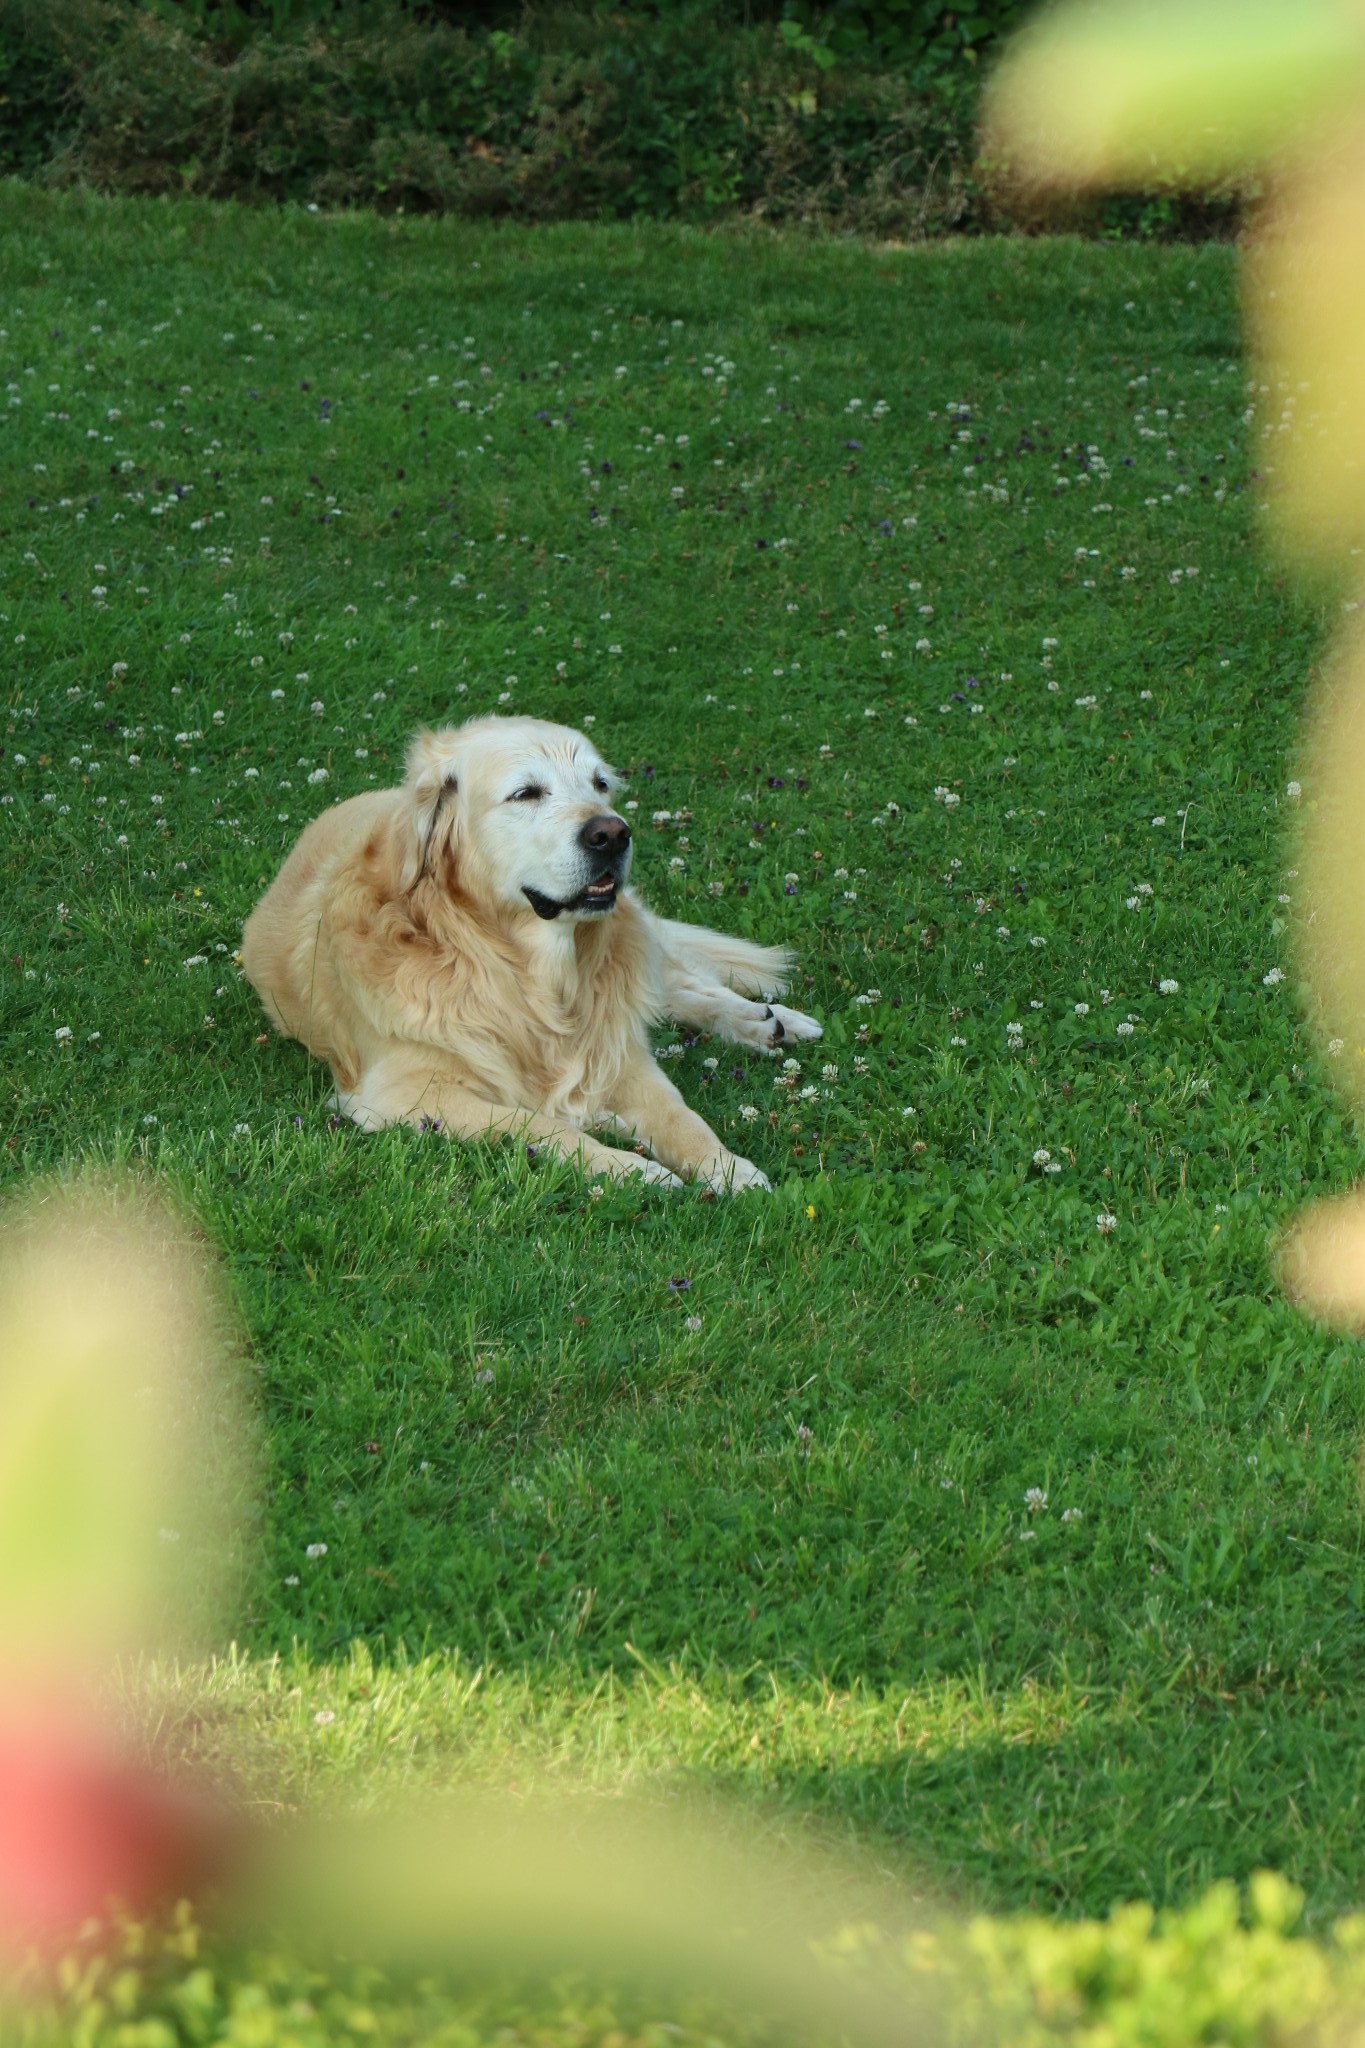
[392,719,630,920]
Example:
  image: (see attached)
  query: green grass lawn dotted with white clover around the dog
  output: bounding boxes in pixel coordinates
[0,184,1365,1974]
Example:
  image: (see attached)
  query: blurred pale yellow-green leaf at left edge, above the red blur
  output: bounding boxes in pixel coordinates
[0,1186,248,1688]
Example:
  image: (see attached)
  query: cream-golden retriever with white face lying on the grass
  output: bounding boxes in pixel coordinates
[241,717,821,1192]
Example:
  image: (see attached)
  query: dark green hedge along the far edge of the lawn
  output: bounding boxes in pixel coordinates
[0,0,1232,238]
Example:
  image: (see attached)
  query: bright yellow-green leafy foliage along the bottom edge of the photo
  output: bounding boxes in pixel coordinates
[15,1874,1365,2048]
